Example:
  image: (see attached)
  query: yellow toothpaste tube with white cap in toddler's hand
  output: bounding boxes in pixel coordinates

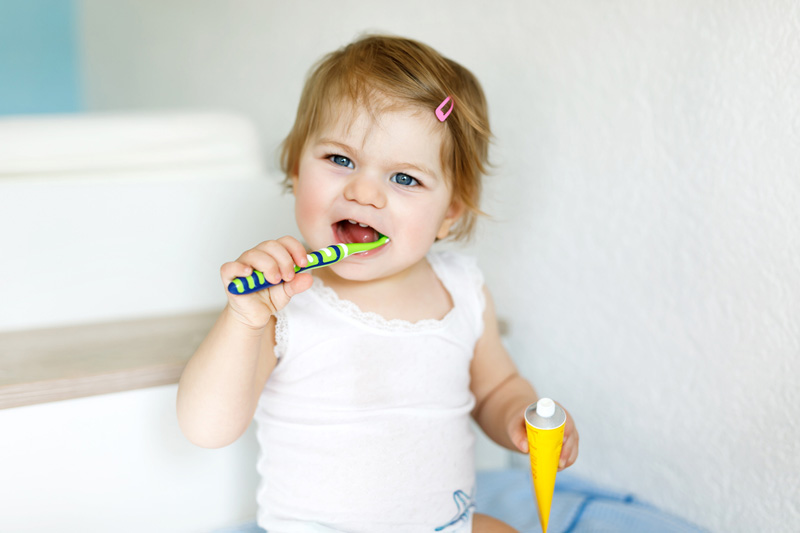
[525,398,567,533]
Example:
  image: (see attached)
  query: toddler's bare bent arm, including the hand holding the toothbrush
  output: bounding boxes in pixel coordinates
[177,237,311,448]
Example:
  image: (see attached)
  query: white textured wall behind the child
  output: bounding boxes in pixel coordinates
[75,0,800,532]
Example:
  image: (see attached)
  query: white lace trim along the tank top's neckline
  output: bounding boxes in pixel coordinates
[310,257,459,330]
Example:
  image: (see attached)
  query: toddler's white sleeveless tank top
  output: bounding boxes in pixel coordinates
[255,252,484,533]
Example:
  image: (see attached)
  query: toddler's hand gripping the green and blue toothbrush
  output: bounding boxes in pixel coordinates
[220,235,312,329]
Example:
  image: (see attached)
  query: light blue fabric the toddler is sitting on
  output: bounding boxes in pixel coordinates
[215,469,706,533]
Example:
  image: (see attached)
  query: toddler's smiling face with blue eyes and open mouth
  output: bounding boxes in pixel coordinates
[292,101,461,281]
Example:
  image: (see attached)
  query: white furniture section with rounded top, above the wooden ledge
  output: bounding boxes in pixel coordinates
[0,111,294,331]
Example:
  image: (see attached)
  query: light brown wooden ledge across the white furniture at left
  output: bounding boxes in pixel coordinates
[0,310,219,409]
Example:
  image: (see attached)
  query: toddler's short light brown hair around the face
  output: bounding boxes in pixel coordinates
[281,35,491,239]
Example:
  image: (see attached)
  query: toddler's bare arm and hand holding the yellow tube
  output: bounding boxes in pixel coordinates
[470,289,578,468]
